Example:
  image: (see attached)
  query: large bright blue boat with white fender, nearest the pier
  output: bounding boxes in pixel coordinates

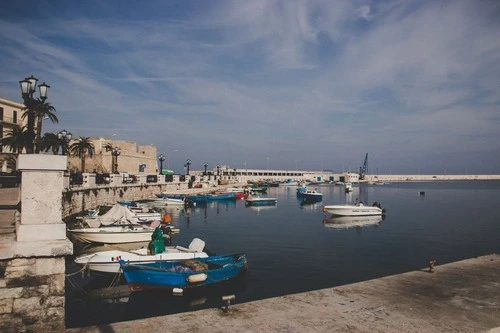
[119,254,247,292]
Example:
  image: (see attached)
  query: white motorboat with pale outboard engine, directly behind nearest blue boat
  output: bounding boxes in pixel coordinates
[75,238,208,273]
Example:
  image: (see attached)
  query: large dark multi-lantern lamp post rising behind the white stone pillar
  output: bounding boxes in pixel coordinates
[19,75,50,154]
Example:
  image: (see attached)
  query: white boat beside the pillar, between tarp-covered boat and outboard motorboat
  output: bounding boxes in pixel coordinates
[68,223,154,244]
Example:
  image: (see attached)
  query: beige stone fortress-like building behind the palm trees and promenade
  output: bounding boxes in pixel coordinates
[68,137,158,174]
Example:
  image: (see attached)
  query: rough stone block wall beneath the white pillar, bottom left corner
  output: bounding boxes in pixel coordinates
[0,257,65,332]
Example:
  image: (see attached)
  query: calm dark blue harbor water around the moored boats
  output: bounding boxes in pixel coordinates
[66,181,500,327]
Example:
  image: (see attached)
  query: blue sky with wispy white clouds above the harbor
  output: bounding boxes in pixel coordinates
[0,0,500,174]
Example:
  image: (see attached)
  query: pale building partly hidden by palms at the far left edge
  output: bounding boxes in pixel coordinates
[0,98,28,172]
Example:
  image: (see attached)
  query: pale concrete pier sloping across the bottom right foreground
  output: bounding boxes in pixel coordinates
[66,254,500,333]
